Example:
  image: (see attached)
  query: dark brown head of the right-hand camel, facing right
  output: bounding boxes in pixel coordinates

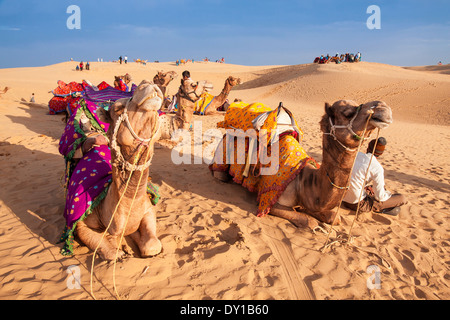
[320,100,393,150]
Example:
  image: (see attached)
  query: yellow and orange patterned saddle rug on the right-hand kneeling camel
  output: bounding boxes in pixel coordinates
[209,102,319,216]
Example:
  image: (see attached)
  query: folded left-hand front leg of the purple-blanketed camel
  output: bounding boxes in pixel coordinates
[76,214,125,261]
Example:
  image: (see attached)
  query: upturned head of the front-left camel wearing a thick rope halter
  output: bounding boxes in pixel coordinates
[97,80,163,169]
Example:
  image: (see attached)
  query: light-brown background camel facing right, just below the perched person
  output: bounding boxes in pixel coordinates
[160,79,213,139]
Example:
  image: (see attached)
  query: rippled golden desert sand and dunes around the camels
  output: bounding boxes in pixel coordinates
[0,62,450,300]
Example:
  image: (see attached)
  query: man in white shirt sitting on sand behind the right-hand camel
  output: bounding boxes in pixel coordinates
[343,137,408,216]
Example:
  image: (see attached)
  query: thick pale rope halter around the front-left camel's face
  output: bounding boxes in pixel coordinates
[111,92,160,171]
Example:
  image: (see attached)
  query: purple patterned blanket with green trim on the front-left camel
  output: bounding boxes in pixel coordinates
[59,99,112,255]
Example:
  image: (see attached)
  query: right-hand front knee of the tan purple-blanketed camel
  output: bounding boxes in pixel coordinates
[131,209,162,257]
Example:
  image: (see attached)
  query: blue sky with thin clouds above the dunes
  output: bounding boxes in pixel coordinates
[0,0,450,68]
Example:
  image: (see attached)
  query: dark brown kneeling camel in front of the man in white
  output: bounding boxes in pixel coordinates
[213,100,392,229]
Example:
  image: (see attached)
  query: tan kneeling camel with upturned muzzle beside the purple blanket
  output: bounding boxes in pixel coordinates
[76,80,163,260]
